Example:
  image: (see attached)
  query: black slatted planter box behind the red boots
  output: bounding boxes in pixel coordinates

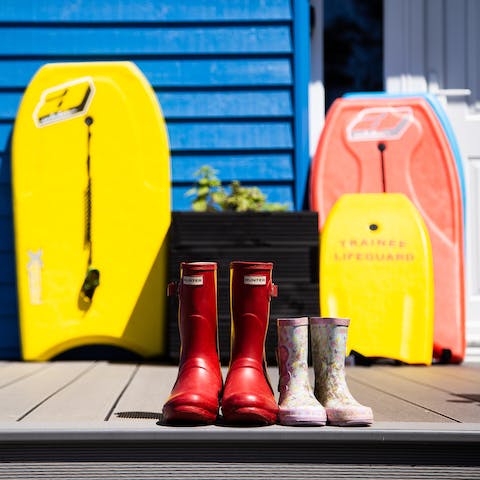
[167,212,320,364]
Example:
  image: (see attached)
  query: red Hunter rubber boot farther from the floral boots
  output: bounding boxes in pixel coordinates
[163,262,222,424]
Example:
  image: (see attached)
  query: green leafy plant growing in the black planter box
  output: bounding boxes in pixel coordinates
[186,165,288,212]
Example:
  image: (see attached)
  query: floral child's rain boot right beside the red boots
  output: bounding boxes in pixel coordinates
[277,317,327,426]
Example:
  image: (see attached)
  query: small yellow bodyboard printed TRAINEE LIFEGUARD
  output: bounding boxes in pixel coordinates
[320,193,434,365]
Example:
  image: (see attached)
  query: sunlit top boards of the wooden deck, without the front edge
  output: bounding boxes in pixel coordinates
[0,361,480,435]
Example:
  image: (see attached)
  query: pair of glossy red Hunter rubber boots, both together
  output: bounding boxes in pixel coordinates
[163,262,278,425]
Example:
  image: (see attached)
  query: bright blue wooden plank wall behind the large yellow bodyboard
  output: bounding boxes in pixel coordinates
[0,0,309,358]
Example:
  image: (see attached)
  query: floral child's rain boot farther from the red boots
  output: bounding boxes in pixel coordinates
[310,317,373,426]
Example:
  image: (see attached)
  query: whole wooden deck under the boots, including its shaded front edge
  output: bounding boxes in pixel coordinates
[0,361,480,479]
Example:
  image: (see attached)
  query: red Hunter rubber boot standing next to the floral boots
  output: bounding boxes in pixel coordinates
[222,262,278,425]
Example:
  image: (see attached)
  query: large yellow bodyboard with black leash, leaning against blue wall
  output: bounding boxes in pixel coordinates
[12,62,171,360]
